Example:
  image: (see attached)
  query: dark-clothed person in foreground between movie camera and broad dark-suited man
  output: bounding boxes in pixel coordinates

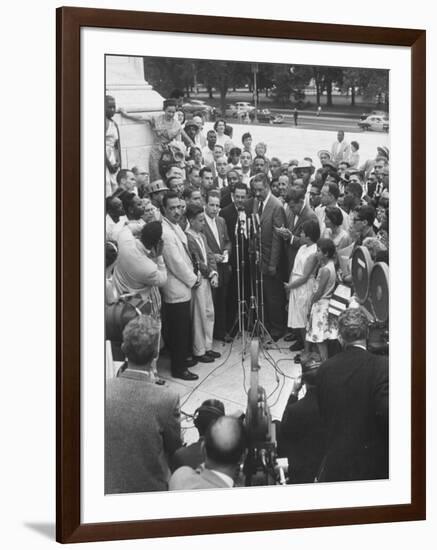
[278,353,325,484]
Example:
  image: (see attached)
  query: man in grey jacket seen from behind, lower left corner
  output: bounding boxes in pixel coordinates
[105,316,182,494]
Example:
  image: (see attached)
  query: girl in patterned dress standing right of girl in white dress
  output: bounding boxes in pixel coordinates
[306,239,337,361]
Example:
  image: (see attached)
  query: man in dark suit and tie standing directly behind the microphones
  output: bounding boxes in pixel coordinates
[220,183,249,333]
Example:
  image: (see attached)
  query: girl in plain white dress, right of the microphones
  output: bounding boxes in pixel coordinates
[284,220,320,351]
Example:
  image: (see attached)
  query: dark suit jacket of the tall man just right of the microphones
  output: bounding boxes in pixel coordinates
[246,193,285,274]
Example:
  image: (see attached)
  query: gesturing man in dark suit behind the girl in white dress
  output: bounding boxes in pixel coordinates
[276,185,317,281]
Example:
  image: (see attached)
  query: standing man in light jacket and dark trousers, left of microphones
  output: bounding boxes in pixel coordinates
[162,192,200,380]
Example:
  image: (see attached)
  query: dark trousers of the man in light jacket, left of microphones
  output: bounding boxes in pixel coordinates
[164,300,191,375]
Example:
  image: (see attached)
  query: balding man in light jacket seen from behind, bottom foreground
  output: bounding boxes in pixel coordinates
[169,416,246,491]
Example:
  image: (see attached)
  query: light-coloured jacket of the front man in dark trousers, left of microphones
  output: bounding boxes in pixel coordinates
[162,218,196,303]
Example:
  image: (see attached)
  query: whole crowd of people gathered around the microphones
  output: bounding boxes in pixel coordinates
[106,96,389,493]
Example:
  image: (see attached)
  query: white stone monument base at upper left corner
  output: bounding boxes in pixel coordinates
[106,55,164,169]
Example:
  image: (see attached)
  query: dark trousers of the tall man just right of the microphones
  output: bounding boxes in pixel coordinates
[263,275,285,338]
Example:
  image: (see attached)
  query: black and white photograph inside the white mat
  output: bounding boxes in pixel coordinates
[101,52,390,495]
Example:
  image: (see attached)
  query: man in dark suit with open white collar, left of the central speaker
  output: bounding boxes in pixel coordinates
[203,190,231,340]
